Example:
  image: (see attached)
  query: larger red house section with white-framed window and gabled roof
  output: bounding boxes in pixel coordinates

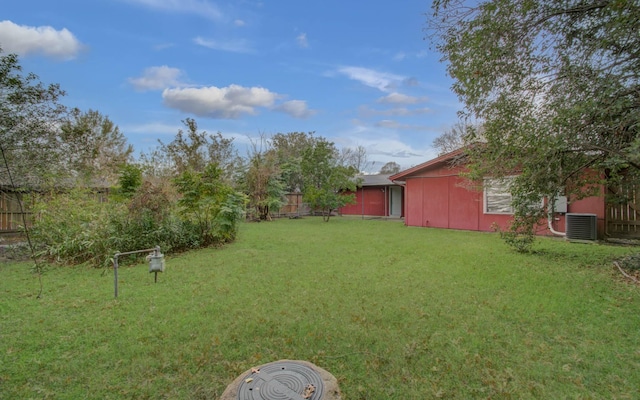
[389,149,611,238]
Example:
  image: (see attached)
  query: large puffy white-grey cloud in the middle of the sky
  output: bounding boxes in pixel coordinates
[162,85,279,119]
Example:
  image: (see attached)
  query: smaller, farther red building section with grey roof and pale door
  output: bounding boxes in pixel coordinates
[338,175,404,218]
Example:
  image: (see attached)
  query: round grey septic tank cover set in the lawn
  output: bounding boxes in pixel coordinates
[221,360,341,400]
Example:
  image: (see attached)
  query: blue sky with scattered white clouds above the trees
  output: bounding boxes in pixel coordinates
[0,0,462,172]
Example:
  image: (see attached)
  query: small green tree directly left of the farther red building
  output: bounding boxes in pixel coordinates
[301,138,358,222]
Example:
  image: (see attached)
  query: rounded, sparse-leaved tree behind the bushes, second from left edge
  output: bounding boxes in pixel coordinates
[61,108,133,186]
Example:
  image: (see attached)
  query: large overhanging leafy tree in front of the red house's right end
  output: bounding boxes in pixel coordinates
[429,0,640,245]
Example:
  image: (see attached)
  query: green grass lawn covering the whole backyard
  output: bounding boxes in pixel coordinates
[0,218,640,400]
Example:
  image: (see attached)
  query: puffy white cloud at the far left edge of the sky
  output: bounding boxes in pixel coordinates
[0,21,83,60]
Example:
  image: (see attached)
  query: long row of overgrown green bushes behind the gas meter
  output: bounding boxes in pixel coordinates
[32,173,245,267]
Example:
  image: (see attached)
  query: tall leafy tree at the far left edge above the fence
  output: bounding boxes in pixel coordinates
[0,49,66,186]
